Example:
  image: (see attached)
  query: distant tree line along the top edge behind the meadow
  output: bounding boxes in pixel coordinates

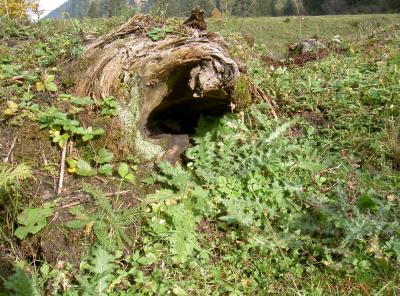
[0,0,400,18]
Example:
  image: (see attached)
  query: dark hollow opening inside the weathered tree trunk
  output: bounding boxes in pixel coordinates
[146,67,231,138]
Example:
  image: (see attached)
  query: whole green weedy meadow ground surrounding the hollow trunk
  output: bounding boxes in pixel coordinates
[0,15,400,296]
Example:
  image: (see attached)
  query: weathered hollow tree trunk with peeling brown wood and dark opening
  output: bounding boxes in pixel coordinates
[72,15,240,159]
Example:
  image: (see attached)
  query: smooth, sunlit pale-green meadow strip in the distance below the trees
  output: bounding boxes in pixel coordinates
[208,14,400,55]
